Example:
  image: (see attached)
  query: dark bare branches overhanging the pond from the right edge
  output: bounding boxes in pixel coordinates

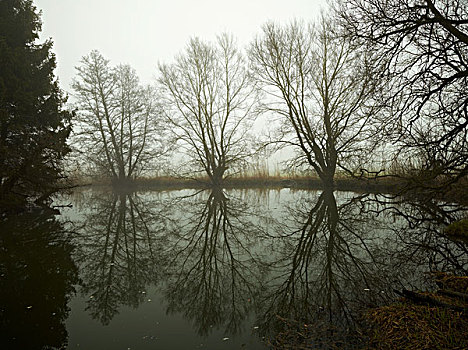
[334,0,468,185]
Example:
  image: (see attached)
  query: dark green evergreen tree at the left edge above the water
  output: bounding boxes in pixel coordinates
[0,0,71,211]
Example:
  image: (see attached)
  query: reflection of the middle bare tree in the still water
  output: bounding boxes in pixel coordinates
[161,188,262,335]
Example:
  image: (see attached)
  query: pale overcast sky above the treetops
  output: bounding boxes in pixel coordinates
[34,0,326,92]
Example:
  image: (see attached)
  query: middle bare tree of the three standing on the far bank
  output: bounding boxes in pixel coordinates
[158,34,254,185]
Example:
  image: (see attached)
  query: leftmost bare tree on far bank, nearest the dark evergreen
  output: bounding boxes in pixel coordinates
[72,51,167,183]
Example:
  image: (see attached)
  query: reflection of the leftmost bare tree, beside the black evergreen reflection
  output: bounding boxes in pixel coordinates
[77,193,167,325]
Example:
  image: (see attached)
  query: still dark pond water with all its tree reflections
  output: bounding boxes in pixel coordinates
[0,189,468,350]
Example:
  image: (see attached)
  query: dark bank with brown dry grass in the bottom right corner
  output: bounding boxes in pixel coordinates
[267,273,468,350]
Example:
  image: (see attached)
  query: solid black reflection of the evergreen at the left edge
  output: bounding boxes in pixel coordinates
[0,209,78,349]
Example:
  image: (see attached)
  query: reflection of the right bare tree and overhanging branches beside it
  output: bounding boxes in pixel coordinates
[260,191,468,347]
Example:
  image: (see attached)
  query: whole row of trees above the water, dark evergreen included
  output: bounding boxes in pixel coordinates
[0,0,468,211]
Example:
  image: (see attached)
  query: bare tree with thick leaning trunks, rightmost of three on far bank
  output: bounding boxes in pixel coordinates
[249,18,379,187]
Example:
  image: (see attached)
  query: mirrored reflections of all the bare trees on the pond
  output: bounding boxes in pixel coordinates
[65,189,468,347]
